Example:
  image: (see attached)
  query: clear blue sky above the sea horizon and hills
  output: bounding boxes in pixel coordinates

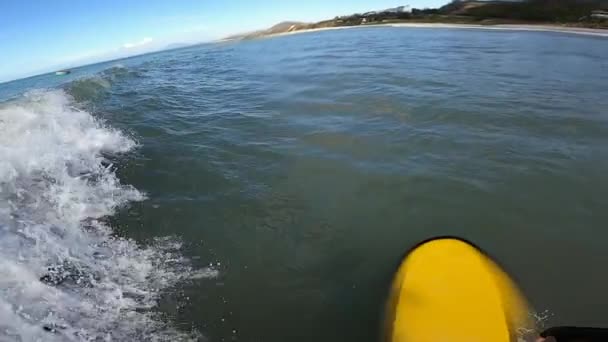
[0,0,447,82]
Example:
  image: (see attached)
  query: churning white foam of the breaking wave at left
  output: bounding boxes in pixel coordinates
[0,91,213,341]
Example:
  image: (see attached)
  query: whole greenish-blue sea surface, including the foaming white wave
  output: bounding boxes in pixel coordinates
[0,28,608,342]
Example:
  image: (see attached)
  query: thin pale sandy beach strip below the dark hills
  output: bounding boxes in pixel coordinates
[232,23,608,42]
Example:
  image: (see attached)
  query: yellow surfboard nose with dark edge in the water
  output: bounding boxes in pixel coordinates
[385,238,533,342]
